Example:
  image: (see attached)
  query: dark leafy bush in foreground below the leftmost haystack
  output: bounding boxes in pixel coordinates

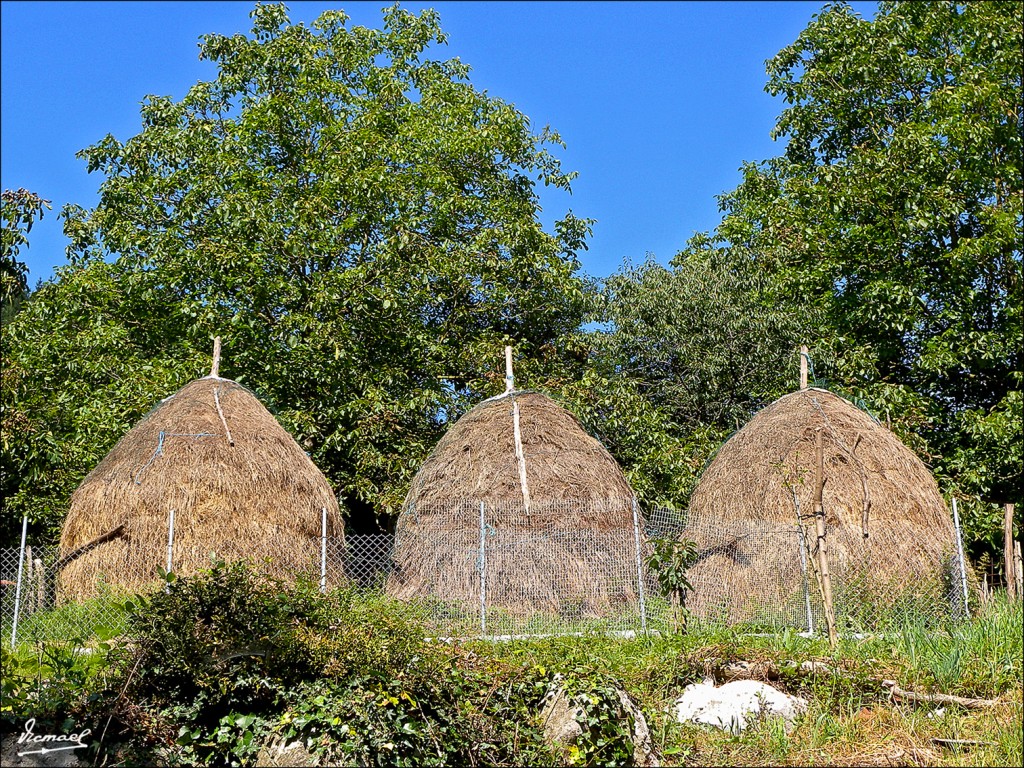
[101,563,544,765]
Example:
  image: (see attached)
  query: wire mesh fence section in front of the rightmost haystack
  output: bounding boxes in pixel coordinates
[647,508,972,634]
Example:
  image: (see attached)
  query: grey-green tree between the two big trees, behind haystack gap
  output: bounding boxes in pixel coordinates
[598,237,807,435]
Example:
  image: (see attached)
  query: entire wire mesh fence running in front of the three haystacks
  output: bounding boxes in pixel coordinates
[0,501,967,643]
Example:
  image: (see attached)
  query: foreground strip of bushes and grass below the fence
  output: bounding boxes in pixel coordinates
[2,564,1024,765]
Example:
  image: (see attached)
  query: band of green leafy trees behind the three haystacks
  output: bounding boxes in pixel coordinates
[0,2,1024,559]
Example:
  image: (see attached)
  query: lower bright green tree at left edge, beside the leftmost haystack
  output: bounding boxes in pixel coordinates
[0,260,193,547]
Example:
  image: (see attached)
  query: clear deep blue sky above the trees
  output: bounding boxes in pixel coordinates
[0,0,876,285]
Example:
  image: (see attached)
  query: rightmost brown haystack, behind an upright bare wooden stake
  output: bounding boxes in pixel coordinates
[685,388,956,621]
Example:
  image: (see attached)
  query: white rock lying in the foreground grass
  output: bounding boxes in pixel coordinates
[675,680,807,733]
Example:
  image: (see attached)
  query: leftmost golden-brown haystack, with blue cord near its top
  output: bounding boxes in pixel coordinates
[57,376,342,600]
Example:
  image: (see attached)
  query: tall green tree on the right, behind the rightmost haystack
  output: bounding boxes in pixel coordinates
[716,2,1024,552]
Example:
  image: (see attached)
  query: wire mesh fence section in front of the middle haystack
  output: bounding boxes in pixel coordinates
[387,500,646,637]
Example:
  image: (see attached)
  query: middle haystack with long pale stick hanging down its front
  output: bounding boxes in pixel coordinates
[388,391,637,617]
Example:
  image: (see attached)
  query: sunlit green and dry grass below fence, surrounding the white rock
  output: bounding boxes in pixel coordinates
[4,595,1024,766]
